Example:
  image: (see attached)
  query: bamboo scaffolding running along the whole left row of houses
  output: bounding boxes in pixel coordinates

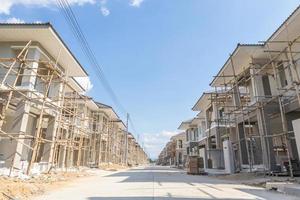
[0,41,146,174]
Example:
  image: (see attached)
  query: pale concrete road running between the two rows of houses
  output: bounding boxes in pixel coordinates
[36,167,300,200]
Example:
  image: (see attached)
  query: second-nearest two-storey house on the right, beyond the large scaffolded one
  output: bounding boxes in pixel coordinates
[192,90,234,172]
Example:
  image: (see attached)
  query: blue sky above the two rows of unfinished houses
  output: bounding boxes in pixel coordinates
[0,0,299,157]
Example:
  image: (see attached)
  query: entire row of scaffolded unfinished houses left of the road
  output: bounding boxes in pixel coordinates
[0,23,147,174]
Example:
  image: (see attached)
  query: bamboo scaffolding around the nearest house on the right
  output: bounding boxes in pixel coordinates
[210,24,300,176]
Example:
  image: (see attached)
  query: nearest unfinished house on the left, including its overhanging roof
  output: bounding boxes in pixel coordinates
[0,24,87,173]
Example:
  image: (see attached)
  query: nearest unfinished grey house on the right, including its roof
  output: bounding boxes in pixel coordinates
[211,8,300,174]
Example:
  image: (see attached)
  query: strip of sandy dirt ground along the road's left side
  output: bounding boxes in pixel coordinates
[0,164,125,200]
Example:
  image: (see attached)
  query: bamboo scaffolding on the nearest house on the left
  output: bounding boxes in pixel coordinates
[0,41,71,174]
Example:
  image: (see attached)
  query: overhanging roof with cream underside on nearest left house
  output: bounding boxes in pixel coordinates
[0,23,88,77]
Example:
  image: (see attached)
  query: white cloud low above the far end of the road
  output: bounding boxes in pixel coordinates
[143,131,179,158]
